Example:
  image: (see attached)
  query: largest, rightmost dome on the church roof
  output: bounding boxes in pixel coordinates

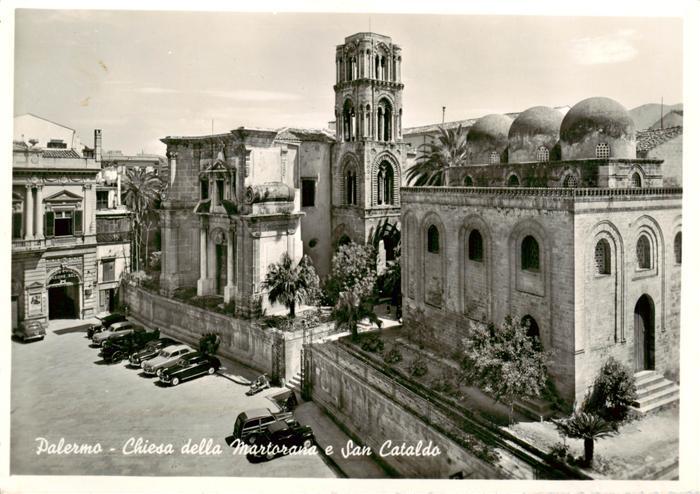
[560,97,636,159]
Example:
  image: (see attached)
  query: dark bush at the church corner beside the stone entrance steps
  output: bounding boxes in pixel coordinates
[582,357,637,427]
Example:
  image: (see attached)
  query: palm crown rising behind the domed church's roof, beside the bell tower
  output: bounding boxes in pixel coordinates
[406,124,469,186]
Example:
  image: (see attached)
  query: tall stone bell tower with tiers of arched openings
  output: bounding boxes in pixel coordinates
[332,33,406,245]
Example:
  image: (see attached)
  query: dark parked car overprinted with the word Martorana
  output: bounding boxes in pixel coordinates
[243,420,315,460]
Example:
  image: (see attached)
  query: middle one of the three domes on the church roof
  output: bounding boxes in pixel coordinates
[508,106,564,163]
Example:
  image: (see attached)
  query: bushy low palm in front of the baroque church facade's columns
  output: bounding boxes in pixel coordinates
[262,252,318,318]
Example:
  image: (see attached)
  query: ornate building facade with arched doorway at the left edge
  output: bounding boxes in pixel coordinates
[11,142,100,327]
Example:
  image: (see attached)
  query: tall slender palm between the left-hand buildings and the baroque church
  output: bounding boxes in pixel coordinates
[123,167,163,271]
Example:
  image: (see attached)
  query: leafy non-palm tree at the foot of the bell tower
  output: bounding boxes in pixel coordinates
[325,242,377,305]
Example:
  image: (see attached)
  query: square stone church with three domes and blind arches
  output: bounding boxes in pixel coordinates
[401,98,682,403]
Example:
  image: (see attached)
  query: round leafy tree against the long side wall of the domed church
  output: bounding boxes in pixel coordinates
[461,316,547,421]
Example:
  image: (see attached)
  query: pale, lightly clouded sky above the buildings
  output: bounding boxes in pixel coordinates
[14,9,683,154]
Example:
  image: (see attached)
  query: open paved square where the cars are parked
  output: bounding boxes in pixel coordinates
[10,322,335,477]
